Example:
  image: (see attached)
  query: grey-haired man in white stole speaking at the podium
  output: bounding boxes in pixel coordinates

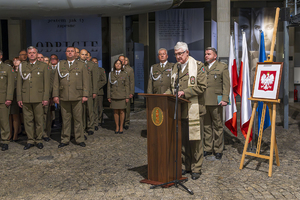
[166,42,207,180]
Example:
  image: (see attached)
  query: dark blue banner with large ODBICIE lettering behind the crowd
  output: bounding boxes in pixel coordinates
[31,17,102,63]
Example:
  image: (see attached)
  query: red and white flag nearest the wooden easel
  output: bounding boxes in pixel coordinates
[237,32,252,142]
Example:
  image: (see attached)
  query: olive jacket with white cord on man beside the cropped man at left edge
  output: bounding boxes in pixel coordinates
[17,60,50,103]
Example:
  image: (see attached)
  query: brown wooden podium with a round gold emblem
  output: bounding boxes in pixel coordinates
[138,93,189,187]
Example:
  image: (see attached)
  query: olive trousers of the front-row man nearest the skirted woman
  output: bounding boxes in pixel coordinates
[60,100,84,144]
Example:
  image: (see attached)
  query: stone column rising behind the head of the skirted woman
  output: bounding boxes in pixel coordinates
[109,16,126,67]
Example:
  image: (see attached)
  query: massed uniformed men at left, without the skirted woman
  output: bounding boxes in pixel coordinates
[0,46,134,151]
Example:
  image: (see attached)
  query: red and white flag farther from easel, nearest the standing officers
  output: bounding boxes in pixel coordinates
[225,36,238,136]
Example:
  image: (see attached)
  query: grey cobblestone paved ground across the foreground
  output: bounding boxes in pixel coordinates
[0,103,300,200]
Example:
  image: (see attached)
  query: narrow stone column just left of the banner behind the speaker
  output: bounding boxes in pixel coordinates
[139,13,150,93]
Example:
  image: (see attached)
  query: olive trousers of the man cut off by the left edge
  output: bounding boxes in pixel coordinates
[0,103,10,144]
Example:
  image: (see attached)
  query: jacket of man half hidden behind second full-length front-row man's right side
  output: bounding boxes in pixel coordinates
[80,60,99,97]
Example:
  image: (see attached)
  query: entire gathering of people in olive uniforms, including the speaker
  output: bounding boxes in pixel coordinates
[0,42,230,180]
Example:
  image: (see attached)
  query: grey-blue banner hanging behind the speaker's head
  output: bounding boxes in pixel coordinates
[155,8,204,63]
